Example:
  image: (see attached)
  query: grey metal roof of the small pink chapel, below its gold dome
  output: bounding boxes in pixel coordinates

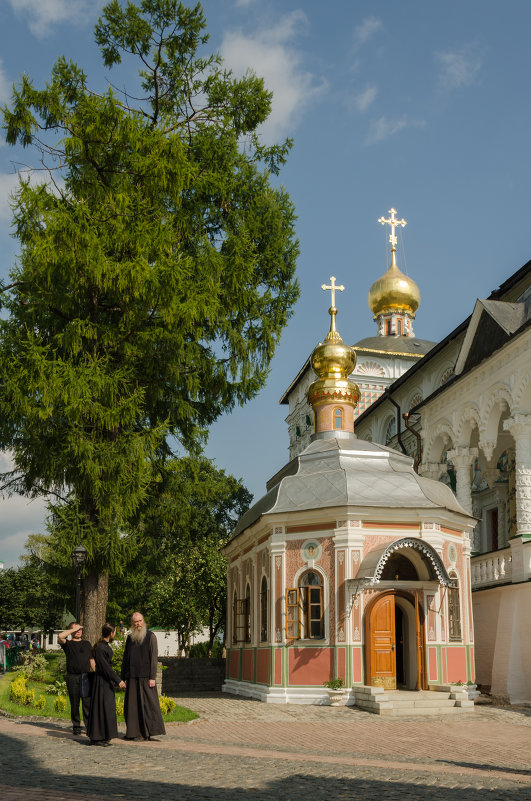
[233,432,471,537]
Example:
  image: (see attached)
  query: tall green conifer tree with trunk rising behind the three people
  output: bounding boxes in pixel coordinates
[0,0,298,637]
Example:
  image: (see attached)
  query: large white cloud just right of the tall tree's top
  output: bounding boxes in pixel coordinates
[221,10,325,143]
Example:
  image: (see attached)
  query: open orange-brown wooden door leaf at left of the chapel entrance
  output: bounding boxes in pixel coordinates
[365,594,396,690]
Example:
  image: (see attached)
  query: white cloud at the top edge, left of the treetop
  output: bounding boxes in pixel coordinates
[9,0,104,38]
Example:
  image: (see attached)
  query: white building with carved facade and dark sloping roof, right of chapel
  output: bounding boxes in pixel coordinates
[356,262,531,703]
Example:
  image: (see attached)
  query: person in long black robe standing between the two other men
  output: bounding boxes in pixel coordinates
[87,623,125,746]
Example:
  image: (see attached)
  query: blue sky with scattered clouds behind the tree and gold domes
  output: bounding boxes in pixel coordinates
[0,0,531,567]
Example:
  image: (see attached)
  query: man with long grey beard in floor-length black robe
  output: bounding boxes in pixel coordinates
[121,612,166,740]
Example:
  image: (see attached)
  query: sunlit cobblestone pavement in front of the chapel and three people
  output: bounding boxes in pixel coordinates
[0,694,531,801]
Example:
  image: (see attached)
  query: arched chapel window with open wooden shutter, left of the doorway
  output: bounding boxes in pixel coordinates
[286,570,324,640]
